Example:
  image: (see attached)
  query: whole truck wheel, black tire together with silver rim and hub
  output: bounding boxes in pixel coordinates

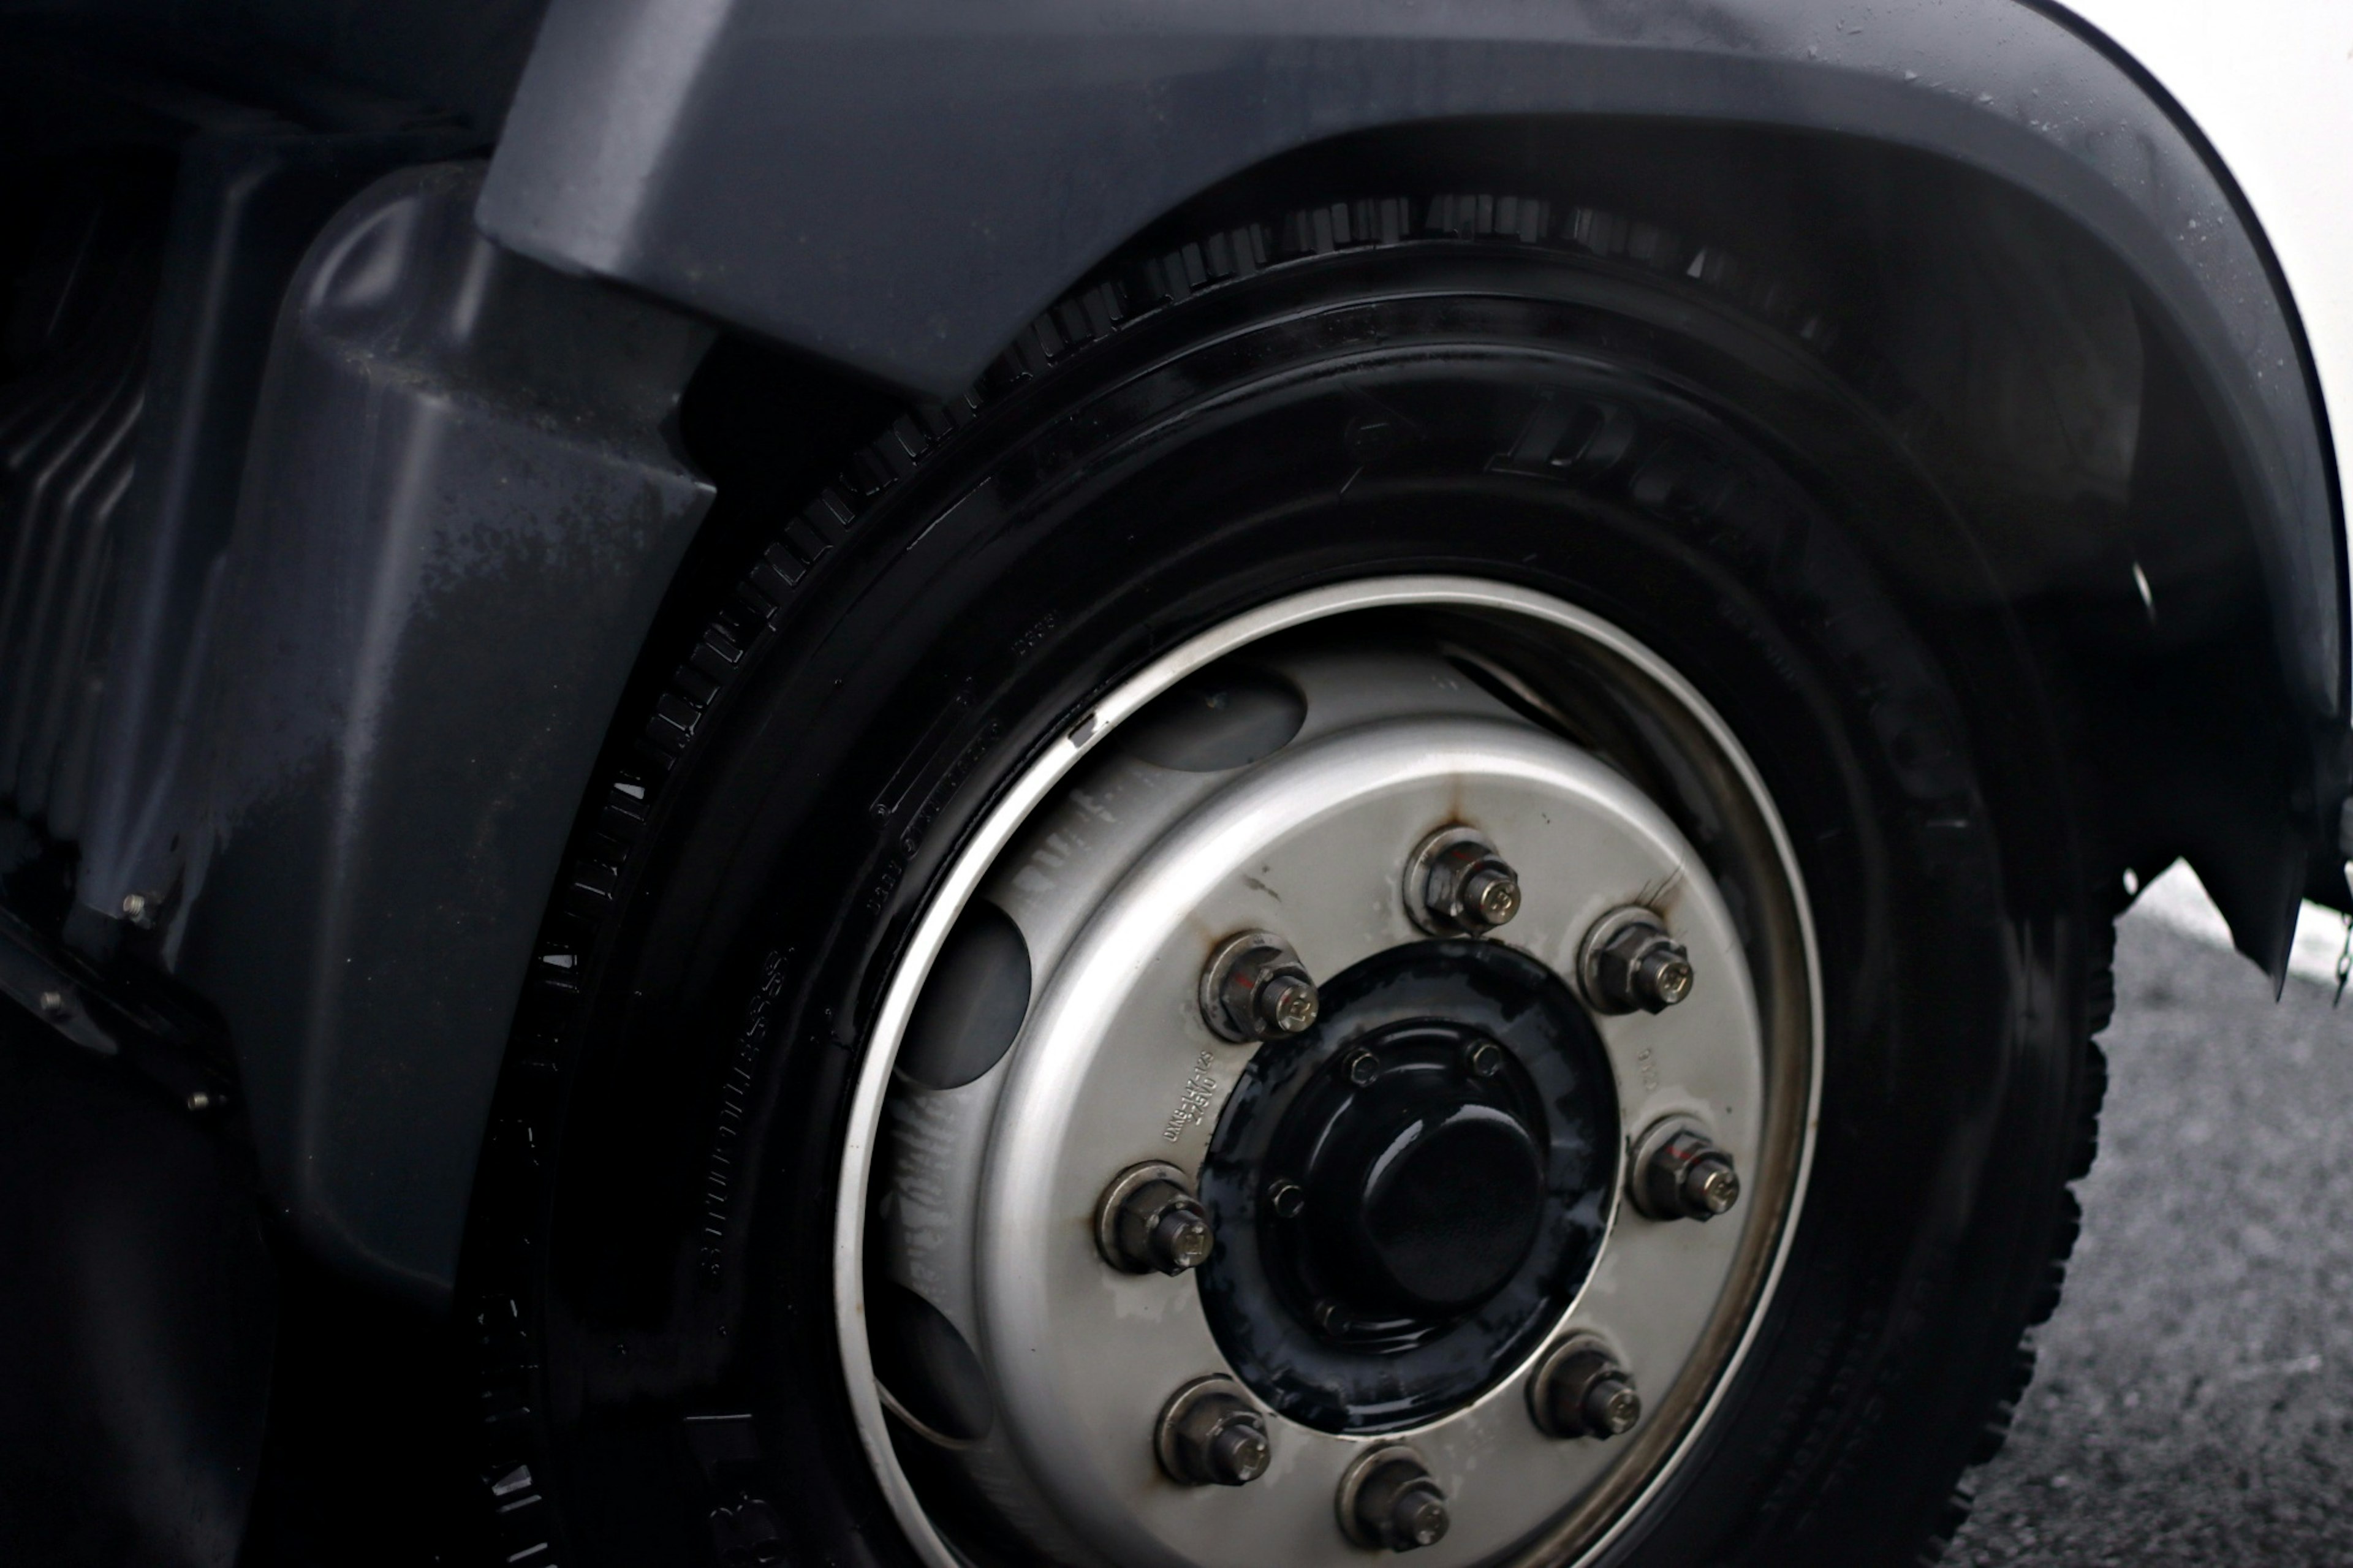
[466,198,2109,1568]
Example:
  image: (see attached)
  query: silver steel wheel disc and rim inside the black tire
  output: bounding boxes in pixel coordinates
[835,579,1819,1566]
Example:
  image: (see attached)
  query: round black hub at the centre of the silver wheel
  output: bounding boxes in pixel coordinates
[1202,942,1616,1431]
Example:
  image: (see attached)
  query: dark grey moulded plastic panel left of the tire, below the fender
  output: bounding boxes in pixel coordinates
[165,165,711,1305]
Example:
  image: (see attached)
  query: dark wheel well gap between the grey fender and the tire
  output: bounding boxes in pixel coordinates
[683,118,2348,965]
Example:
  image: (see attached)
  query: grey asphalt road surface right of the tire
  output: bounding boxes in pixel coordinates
[1946,916,2353,1568]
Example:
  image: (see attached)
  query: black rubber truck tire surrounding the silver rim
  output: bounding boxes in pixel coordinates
[466,198,2109,1568]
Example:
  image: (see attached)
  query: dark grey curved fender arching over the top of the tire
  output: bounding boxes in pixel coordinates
[478,0,2346,720]
